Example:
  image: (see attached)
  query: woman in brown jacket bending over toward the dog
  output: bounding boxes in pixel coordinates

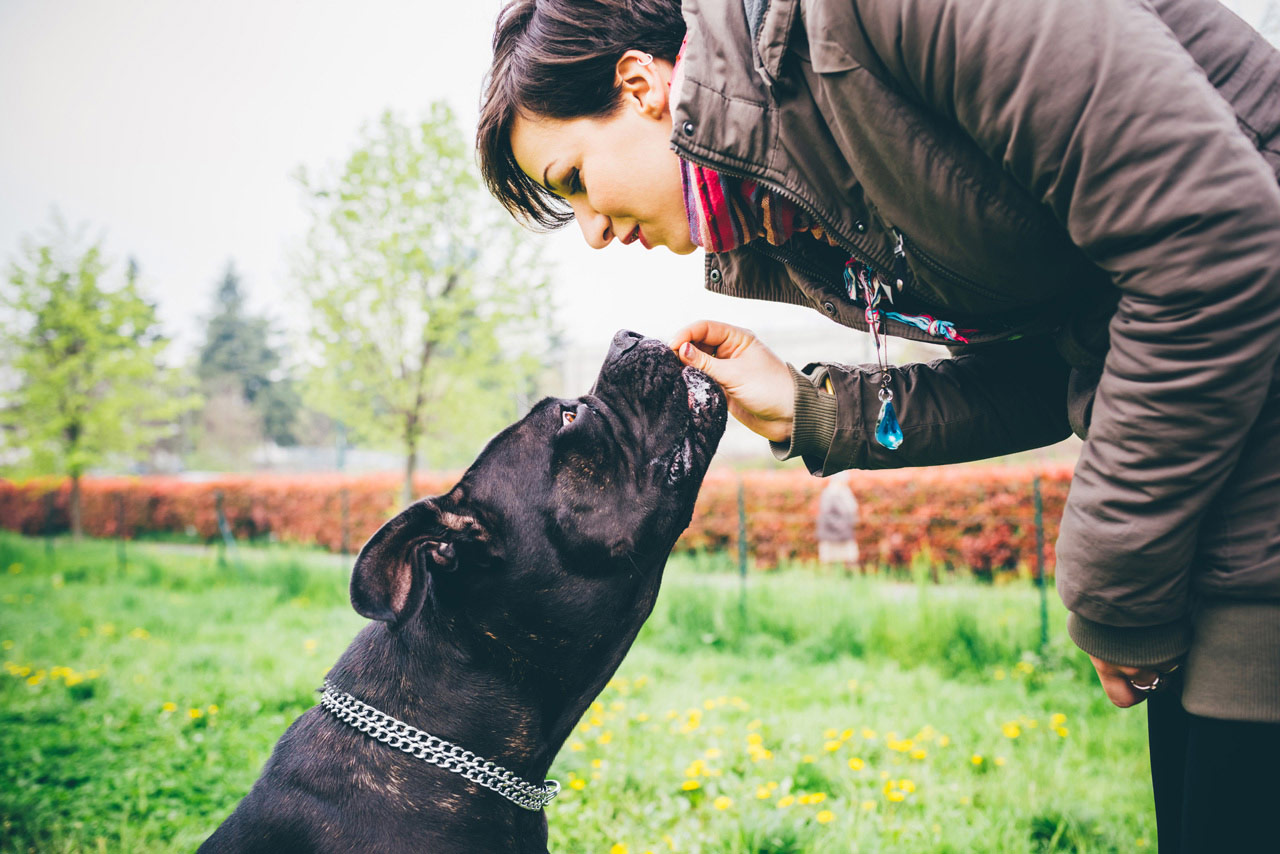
[477,0,1280,851]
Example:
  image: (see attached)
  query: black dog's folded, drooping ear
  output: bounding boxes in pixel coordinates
[351,498,488,626]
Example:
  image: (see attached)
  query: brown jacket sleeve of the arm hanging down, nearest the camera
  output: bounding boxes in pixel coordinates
[845,0,1280,665]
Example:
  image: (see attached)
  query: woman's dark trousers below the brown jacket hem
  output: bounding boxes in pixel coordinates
[1147,681,1280,854]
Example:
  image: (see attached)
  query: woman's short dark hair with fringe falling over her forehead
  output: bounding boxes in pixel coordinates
[476,0,685,229]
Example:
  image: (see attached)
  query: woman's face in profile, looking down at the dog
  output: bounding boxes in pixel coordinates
[511,51,698,255]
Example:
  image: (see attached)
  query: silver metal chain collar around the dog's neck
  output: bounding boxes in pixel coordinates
[320,680,559,813]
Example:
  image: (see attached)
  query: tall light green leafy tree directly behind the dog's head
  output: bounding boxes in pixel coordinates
[297,104,550,502]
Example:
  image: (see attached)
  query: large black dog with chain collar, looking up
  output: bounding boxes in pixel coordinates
[200,332,726,854]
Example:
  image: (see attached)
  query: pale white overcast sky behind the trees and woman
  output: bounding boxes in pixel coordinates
[0,0,1274,361]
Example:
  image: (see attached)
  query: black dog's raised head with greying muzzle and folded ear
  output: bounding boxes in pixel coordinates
[351,332,727,654]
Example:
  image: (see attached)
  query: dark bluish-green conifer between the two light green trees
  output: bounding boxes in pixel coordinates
[196,262,301,452]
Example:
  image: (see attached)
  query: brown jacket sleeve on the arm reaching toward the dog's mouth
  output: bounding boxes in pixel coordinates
[772,339,1071,475]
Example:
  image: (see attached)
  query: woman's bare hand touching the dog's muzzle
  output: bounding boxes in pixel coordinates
[671,320,795,442]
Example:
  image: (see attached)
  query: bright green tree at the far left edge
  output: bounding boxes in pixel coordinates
[0,220,195,538]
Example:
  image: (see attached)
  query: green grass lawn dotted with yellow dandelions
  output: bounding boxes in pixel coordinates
[0,535,1155,854]
